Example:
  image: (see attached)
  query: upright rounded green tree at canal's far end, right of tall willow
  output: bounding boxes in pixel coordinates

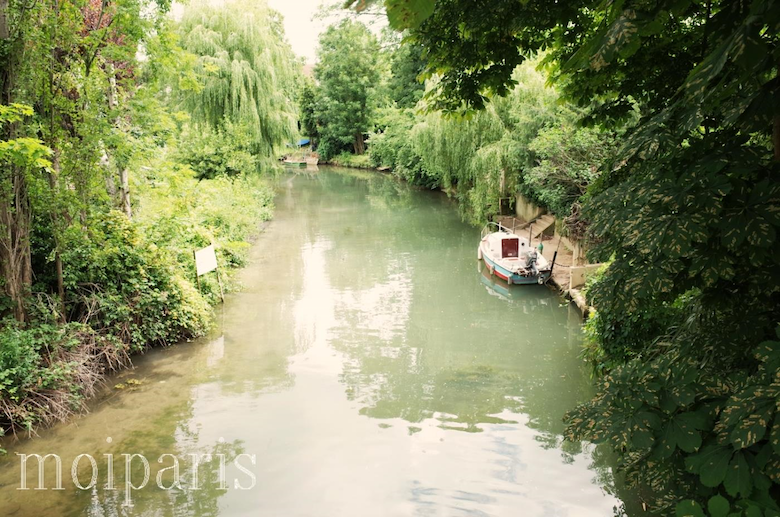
[314,19,379,159]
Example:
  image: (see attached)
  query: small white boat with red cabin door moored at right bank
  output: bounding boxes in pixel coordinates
[477,223,552,285]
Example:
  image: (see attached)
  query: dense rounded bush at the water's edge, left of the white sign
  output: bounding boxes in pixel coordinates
[62,211,209,351]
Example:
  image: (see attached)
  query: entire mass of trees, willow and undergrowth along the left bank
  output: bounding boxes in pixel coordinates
[0,0,299,433]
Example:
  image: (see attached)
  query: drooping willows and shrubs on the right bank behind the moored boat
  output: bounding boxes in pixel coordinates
[368,61,615,224]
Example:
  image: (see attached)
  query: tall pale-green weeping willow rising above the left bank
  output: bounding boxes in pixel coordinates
[180,0,297,160]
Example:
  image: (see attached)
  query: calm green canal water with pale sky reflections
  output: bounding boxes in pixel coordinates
[0,167,621,517]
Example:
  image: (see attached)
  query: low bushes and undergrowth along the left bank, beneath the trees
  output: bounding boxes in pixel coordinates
[0,163,273,442]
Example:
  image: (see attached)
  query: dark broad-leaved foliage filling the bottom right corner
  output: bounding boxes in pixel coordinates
[568,328,780,516]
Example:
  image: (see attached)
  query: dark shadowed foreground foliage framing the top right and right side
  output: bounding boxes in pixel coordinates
[347,0,780,516]
